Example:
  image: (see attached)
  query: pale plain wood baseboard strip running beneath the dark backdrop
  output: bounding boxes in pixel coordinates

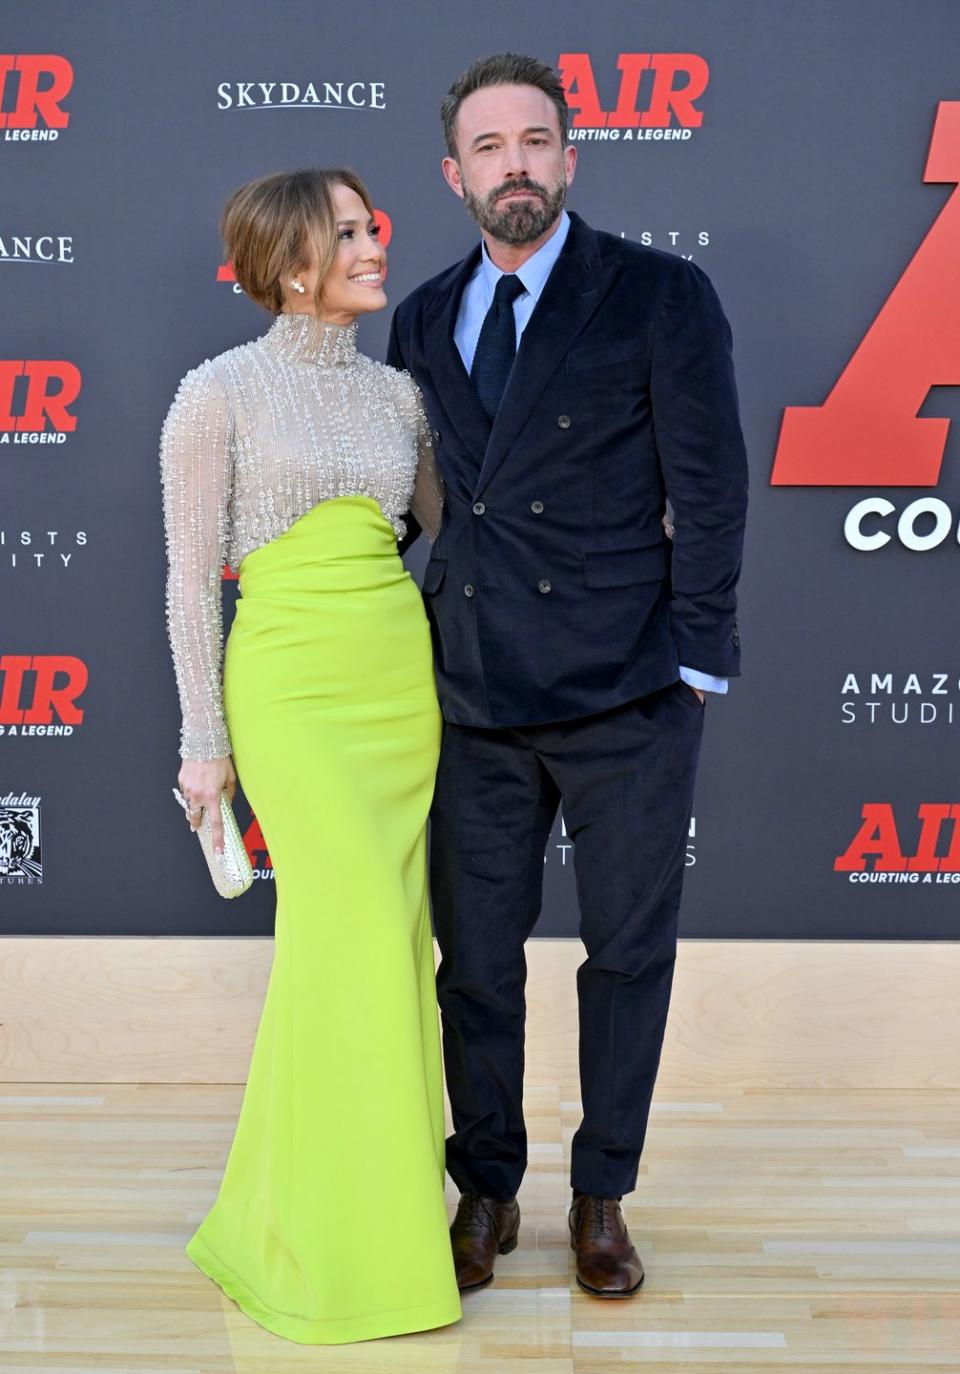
[0,937,960,1088]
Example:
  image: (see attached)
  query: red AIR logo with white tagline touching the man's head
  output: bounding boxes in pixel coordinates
[558,52,710,143]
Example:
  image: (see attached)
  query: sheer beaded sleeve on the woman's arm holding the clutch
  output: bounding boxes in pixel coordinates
[161,364,233,760]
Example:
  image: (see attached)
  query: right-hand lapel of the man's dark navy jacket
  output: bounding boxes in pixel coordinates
[475,214,611,496]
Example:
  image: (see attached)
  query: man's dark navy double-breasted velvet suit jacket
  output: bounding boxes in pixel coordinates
[387,214,747,728]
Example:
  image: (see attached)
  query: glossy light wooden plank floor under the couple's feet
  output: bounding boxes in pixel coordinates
[0,1077,960,1374]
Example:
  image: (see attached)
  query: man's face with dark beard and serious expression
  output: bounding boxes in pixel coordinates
[444,85,577,246]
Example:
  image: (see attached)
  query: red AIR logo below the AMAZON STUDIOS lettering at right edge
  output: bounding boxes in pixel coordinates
[834,801,960,883]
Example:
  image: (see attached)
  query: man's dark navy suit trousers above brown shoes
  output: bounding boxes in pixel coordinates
[430,682,703,1200]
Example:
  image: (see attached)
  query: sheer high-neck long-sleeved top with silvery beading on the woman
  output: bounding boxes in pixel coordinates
[161,315,442,758]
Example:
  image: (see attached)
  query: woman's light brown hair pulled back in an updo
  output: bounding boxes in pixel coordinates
[220,168,374,315]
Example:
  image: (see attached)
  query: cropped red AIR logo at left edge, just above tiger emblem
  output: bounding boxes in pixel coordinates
[0,654,89,735]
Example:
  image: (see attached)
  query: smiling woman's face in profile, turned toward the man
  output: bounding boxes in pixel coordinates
[286,185,387,324]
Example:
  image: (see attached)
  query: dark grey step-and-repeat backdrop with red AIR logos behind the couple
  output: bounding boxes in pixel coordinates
[0,0,960,938]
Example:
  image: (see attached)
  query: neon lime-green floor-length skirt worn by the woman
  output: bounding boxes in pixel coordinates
[187,496,460,1344]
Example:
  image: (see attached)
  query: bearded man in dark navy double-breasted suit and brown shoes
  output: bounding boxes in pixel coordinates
[389,54,747,1297]
